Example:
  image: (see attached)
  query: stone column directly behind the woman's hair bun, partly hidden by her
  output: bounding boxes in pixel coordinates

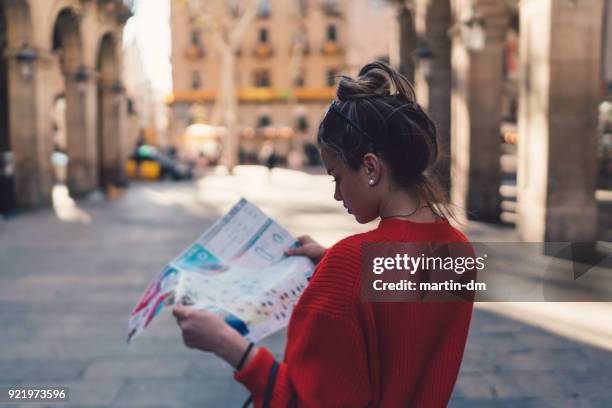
[415,0,452,191]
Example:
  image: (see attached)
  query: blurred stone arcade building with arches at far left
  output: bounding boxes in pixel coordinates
[0,0,131,207]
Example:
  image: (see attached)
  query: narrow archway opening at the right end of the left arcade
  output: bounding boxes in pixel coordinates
[97,33,124,190]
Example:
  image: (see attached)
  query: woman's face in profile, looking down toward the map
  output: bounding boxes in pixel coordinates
[321,147,378,224]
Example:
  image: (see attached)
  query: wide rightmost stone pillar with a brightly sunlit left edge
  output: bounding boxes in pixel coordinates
[518,0,603,242]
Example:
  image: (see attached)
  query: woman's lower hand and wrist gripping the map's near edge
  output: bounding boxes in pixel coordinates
[172,304,255,368]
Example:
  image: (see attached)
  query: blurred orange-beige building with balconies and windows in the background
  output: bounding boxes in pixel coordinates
[167,0,386,166]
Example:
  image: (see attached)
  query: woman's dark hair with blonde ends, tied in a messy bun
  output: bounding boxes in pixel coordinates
[317,61,454,218]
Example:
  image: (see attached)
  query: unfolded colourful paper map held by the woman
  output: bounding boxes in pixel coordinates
[128,199,314,342]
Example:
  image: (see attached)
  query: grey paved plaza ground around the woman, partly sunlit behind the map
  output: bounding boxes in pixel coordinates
[0,168,612,407]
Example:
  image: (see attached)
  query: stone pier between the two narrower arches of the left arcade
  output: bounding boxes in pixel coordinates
[66,71,98,197]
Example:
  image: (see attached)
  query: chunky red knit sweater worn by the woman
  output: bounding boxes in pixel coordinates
[235,219,472,407]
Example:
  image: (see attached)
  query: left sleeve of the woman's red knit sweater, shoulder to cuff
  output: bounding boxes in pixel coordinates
[235,239,372,407]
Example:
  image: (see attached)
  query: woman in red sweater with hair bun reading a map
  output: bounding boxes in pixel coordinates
[174,62,472,407]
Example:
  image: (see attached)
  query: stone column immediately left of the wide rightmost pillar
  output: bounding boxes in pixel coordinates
[451,0,506,222]
